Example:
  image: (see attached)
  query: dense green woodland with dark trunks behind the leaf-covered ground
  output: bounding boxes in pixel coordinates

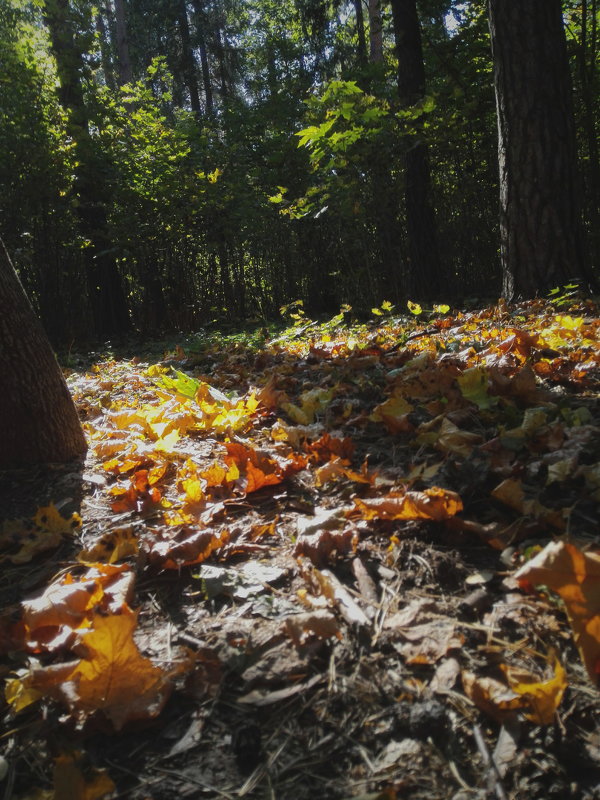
[0,0,600,342]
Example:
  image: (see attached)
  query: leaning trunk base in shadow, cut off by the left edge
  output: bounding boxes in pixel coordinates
[0,241,87,469]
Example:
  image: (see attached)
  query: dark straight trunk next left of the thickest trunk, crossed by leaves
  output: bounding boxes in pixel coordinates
[392,0,440,299]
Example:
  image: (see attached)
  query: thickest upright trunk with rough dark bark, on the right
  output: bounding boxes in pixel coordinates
[489,0,584,299]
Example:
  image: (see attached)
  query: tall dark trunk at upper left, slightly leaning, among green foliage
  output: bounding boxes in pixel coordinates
[44,0,129,336]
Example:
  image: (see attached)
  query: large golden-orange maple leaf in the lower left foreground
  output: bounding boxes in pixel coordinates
[31,607,172,730]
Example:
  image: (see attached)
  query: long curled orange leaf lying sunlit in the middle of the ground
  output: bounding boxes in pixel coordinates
[354,486,463,522]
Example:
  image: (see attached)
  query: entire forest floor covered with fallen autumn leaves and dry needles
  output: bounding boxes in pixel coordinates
[0,297,600,800]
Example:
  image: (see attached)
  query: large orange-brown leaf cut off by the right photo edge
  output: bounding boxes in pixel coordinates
[514,541,600,687]
